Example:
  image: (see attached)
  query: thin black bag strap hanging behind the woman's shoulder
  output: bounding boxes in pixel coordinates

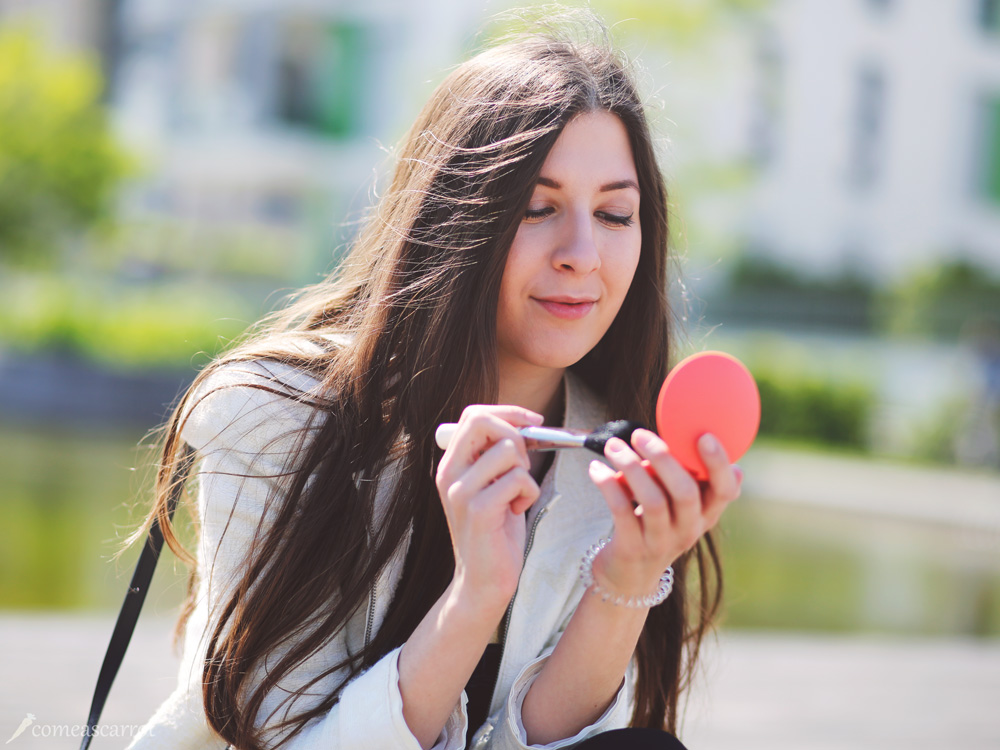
[80,445,194,750]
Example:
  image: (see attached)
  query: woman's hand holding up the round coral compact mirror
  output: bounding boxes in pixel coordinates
[590,430,743,596]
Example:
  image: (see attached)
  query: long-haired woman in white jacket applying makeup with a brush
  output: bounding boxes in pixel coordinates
[127,16,740,750]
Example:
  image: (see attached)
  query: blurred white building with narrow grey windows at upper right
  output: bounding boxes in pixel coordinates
[740,0,1000,278]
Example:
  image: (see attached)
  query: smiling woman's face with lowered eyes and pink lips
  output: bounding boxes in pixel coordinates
[497,111,642,382]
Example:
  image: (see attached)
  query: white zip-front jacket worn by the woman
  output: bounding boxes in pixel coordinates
[129,362,634,750]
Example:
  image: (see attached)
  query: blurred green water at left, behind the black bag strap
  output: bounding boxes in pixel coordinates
[0,419,191,610]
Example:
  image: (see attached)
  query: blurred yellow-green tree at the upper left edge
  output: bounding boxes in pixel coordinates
[0,28,134,264]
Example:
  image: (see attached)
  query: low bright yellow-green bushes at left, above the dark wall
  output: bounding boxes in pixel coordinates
[0,276,255,368]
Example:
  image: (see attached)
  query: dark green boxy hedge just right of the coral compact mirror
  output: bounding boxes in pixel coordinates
[754,369,875,449]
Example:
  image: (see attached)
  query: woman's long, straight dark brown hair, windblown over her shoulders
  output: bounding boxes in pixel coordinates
[132,14,721,750]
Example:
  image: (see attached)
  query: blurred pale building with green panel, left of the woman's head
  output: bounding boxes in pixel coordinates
[103,0,481,278]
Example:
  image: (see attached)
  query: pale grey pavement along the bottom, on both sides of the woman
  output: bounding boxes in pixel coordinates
[0,613,1000,750]
